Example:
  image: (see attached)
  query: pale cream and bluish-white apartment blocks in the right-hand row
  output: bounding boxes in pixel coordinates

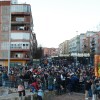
[58,33,86,56]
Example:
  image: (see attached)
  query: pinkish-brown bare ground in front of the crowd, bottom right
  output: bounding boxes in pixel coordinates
[53,93,92,100]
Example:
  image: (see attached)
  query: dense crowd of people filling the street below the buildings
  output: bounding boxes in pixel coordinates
[1,58,100,100]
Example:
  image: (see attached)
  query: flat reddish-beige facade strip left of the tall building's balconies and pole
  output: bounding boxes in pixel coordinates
[0,0,11,65]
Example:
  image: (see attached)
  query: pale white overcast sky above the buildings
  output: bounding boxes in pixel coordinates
[19,0,100,47]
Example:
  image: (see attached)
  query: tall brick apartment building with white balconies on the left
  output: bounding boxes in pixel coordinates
[0,0,37,66]
